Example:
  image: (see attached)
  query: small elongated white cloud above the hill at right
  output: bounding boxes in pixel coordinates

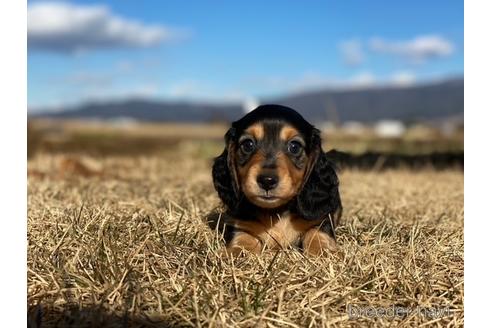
[369,35,454,63]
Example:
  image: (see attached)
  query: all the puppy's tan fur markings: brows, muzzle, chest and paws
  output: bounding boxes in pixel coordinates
[227,123,335,256]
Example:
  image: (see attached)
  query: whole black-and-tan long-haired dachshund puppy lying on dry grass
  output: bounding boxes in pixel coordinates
[212,105,342,256]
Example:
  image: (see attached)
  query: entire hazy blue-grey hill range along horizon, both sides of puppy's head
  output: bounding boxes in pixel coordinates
[30,78,464,122]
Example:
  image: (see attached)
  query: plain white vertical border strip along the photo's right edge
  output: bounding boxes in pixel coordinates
[466,1,492,327]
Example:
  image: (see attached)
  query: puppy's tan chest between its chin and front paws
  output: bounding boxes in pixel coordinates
[235,212,319,248]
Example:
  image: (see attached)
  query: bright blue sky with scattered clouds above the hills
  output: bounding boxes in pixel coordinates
[28,0,463,109]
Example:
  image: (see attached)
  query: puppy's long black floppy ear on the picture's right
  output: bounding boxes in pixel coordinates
[297,129,342,224]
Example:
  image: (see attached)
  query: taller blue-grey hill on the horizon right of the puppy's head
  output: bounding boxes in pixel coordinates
[270,79,464,122]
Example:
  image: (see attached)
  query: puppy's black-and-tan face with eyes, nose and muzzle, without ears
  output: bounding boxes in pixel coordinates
[234,120,309,208]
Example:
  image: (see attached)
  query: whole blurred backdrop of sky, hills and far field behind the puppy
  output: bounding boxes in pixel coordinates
[28,0,464,165]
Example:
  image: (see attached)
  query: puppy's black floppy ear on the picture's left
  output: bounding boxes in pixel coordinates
[212,128,240,212]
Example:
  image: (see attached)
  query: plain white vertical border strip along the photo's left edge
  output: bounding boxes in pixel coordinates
[0,0,27,327]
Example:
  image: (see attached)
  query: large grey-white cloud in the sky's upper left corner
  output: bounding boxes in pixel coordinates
[27,2,186,53]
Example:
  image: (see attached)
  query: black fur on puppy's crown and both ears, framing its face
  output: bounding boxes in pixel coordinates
[212,105,342,232]
